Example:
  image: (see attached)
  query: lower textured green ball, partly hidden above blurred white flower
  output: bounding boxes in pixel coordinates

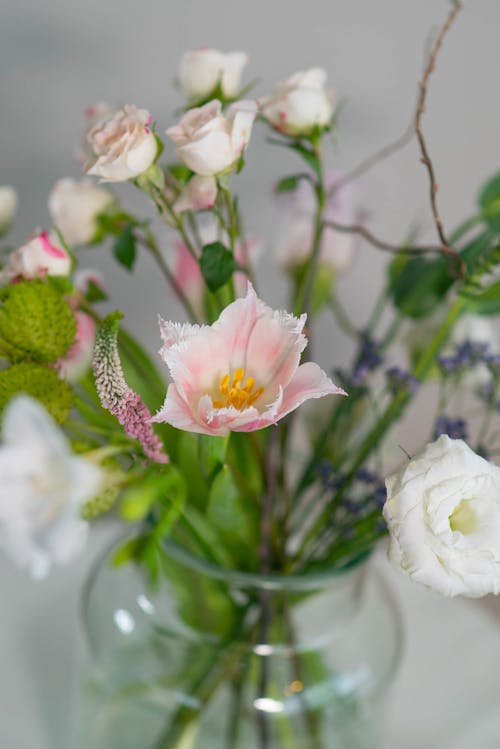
[0,362,74,424]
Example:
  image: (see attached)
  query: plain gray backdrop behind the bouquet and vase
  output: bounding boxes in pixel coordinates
[0,0,500,749]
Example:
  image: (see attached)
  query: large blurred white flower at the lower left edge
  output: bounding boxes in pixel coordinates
[0,395,102,578]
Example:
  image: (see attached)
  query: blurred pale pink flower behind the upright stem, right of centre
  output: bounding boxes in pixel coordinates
[276,171,361,273]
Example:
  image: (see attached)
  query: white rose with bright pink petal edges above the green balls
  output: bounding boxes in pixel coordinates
[2,231,71,281]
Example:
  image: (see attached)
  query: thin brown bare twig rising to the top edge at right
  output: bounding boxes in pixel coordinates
[415,0,465,276]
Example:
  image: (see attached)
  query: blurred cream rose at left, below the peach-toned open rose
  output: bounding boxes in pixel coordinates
[49,178,114,245]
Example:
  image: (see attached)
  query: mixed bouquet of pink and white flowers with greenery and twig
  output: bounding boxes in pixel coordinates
[0,5,500,749]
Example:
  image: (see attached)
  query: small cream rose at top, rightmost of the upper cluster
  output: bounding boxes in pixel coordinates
[259,68,334,135]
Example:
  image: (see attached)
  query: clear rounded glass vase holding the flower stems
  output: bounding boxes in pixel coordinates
[77,543,401,749]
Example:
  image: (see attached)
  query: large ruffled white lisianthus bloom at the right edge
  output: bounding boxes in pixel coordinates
[383,435,500,598]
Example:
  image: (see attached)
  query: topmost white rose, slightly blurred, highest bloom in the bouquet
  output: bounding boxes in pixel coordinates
[178,48,248,100]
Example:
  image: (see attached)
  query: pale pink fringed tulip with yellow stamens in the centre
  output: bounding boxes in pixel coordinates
[153,284,345,436]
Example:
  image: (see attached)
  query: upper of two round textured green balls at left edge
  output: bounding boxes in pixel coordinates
[0,281,76,363]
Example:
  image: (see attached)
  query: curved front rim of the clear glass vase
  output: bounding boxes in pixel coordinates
[162,539,372,590]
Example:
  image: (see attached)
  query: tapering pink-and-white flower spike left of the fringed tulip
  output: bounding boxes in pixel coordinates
[93,313,169,463]
